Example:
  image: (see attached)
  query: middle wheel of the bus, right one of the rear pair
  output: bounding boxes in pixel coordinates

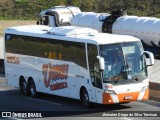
[28,80,37,98]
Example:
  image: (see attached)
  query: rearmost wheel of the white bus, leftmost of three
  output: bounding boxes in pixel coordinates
[20,80,28,96]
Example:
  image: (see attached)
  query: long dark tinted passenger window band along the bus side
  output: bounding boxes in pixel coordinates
[5,34,87,68]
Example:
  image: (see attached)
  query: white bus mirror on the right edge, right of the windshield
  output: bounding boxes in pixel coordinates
[144,51,154,66]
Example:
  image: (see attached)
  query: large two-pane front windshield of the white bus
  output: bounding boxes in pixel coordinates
[100,42,148,83]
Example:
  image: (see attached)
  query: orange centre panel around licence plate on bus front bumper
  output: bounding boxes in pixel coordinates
[117,92,140,103]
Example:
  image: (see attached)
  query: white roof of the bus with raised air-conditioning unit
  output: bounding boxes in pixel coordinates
[5,25,140,44]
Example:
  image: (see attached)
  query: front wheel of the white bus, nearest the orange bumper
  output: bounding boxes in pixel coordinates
[81,89,91,108]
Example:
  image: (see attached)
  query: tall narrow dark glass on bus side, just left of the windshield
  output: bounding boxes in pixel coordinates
[87,44,102,88]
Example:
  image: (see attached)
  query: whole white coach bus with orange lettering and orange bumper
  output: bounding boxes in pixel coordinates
[4,25,154,107]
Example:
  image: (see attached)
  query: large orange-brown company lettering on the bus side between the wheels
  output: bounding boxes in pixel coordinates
[42,63,69,91]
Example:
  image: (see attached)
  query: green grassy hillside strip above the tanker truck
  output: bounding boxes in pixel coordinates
[0,0,160,19]
